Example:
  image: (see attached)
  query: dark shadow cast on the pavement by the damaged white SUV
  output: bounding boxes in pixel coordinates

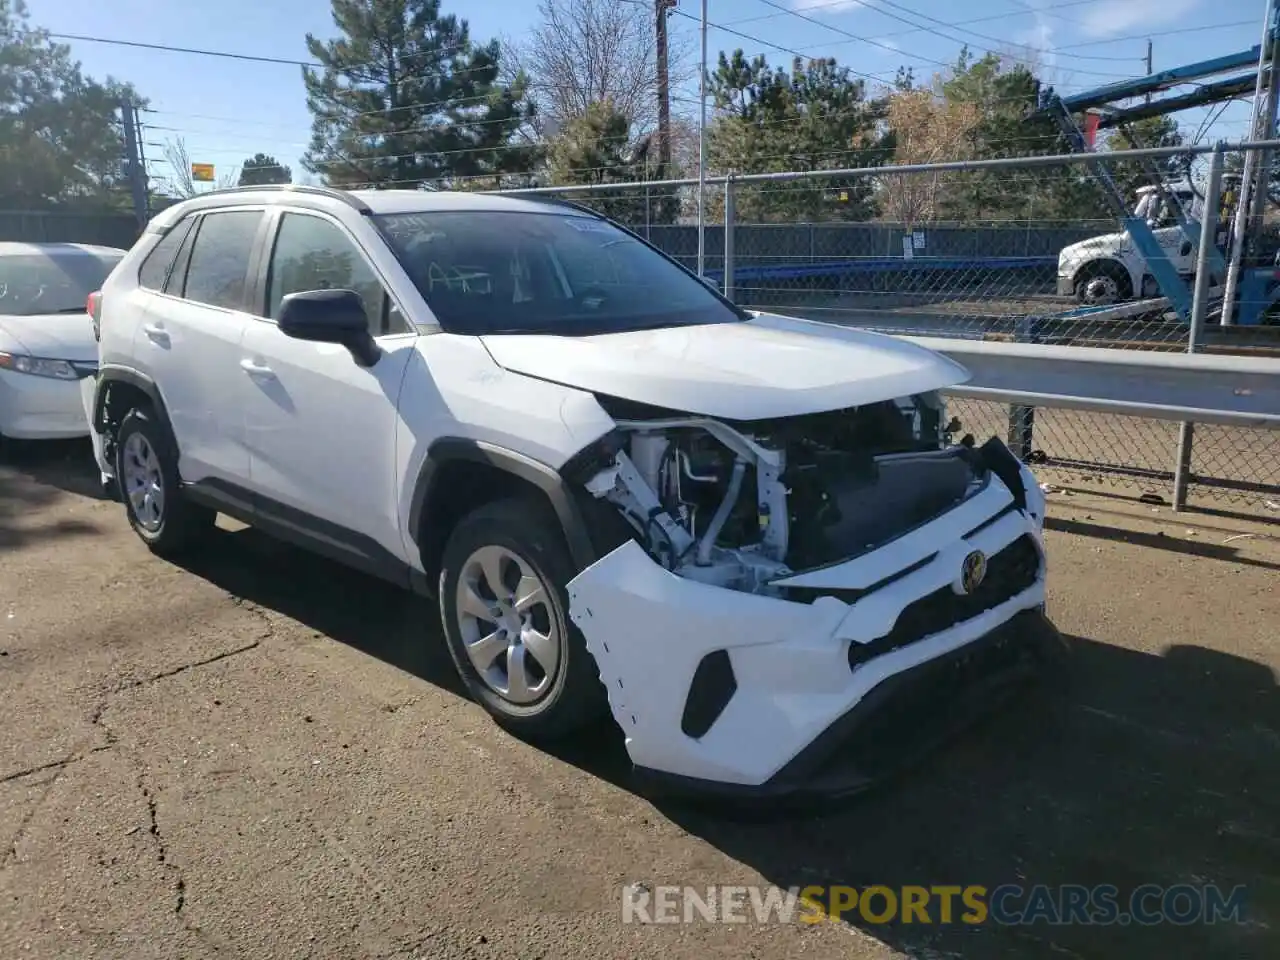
[175,530,1280,960]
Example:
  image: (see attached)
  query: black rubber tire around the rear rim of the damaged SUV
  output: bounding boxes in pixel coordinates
[115,407,218,556]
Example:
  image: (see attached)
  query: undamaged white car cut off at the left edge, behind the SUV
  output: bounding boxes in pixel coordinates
[0,243,124,440]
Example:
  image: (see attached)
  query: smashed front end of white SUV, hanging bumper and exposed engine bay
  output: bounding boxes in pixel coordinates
[566,393,1052,795]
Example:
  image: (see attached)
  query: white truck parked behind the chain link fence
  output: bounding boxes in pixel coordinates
[1057,180,1203,306]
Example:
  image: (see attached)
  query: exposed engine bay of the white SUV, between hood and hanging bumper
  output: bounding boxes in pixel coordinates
[584,393,986,595]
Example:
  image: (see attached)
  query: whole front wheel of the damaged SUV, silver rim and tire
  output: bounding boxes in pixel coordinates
[439,499,607,740]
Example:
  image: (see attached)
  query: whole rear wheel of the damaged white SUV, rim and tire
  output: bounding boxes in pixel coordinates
[115,408,218,554]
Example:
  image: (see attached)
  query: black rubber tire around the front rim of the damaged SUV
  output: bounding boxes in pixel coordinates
[439,499,608,740]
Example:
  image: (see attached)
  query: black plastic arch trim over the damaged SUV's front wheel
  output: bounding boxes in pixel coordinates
[408,436,600,586]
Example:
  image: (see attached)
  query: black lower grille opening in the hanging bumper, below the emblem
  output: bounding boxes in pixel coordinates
[849,534,1039,669]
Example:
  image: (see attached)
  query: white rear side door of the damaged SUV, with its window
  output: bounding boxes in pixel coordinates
[143,207,265,485]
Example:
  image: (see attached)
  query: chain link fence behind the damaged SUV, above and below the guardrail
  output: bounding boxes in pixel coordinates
[496,140,1280,520]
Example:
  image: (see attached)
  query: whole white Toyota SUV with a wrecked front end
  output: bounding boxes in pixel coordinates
[93,187,1056,795]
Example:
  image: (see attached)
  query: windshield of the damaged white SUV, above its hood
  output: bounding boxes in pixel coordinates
[376,210,745,337]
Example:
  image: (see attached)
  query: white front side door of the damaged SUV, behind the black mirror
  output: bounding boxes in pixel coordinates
[239,212,421,566]
